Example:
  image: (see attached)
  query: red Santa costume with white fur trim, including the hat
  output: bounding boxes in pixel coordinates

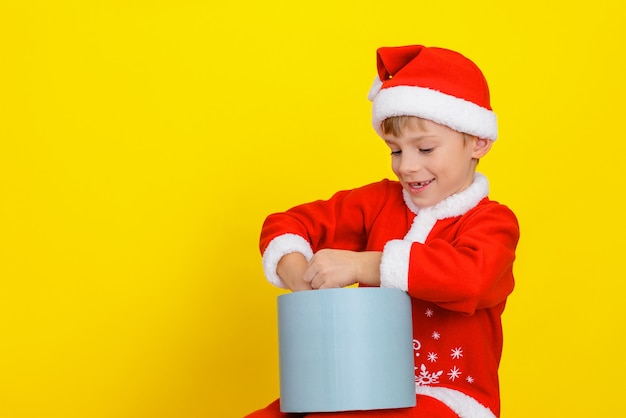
[250,46,519,418]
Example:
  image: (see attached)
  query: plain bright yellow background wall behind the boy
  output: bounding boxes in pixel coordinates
[0,0,626,418]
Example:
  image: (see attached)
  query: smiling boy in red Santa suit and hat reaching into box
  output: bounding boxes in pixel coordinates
[250,45,519,418]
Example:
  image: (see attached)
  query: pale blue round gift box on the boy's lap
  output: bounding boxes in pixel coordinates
[278,287,415,412]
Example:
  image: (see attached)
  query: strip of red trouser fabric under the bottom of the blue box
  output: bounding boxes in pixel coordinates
[246,395,458,418]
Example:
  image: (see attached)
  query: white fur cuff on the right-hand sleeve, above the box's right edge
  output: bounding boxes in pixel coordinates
[380,239,412,291]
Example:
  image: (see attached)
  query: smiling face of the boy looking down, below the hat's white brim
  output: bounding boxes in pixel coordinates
[383,118,491,208]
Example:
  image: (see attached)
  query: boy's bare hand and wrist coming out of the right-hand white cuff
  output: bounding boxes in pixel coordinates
[303,249,382,289]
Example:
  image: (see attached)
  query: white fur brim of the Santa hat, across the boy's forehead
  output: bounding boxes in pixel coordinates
[370,85,498,141]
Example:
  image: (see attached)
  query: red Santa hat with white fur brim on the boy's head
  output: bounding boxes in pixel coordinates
[368,45,498,140]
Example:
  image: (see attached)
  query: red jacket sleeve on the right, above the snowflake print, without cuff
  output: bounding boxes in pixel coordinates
[408,202,519,314]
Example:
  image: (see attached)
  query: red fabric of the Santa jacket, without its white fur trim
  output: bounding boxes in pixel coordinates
[260,180,519,416]
